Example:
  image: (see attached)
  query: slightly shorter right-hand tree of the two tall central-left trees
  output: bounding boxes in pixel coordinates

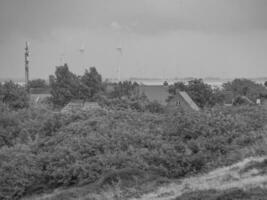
[81,67,103,99]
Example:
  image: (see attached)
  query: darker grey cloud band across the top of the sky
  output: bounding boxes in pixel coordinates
[0,0,267,38]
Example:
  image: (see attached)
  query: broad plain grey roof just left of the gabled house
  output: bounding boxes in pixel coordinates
[139,85,169,105]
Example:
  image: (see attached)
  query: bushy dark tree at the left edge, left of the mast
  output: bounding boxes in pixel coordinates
[0,81,30,109]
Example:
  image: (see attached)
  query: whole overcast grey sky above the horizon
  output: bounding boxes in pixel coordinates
[0,0,267,78]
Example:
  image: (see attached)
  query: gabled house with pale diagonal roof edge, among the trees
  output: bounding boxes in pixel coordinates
[167,91,200,111]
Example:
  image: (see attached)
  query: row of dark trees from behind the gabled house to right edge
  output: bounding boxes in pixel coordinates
[169,79,267,108]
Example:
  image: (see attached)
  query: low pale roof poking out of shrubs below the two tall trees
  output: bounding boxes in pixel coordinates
[61,100,102,113]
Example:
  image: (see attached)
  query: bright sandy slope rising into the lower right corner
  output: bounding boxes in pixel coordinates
[131,156,267,200]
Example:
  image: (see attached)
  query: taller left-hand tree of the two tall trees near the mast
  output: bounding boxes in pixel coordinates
[49,64,81,106]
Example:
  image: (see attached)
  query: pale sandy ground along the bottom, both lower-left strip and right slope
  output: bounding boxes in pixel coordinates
[23,156,267,200]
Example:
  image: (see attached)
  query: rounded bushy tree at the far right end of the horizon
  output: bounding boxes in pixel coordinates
[223,79,267,102]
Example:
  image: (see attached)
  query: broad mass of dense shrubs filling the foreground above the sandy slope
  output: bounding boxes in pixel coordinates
[0,107,267,199]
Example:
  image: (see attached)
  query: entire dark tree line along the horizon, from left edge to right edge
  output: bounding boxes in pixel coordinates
[0,64,267,112]
